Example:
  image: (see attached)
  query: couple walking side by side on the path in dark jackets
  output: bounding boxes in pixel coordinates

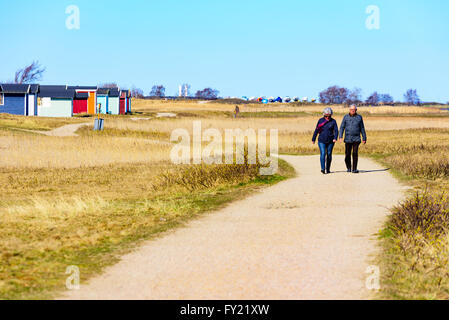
[312,105,366,174]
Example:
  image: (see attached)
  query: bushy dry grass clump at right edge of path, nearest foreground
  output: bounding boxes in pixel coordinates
[381,192,449,300]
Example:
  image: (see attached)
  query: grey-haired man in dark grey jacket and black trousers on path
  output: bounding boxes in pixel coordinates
[340,105,366,173]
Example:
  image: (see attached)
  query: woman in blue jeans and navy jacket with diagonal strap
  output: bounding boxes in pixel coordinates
[312,108,338,174]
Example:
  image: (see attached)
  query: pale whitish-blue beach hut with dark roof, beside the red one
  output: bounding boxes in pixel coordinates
[37,86,76,117]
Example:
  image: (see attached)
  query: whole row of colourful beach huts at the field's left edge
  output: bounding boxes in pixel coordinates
[0,84,131,117]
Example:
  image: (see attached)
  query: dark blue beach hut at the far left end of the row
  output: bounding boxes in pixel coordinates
[0,84,30,116]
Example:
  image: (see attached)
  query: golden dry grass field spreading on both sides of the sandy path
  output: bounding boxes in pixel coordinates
[0,100,449,299]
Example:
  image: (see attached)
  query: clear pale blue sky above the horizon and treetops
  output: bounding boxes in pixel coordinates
[0,0,449,102]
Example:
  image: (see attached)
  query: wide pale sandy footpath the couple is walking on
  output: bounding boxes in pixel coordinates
[62,156,405,300]
